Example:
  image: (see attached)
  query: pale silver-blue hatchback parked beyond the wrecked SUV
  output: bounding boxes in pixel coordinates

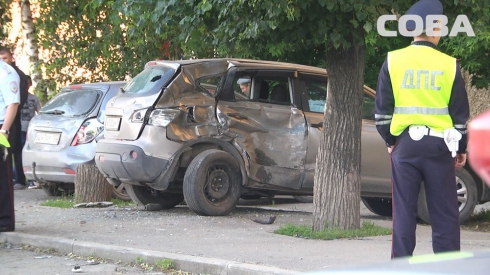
[22,81,129,200]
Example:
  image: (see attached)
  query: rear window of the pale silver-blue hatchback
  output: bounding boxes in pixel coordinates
[40,89,102,116]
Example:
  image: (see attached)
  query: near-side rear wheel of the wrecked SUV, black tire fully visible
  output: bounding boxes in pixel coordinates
[184,149,241,216]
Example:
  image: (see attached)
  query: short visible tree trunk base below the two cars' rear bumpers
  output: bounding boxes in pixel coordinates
[74,164,112,203]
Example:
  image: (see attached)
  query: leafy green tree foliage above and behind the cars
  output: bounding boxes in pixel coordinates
[33,0,490,98]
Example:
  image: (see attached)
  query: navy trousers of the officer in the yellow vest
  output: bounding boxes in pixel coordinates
[391,131,460,258]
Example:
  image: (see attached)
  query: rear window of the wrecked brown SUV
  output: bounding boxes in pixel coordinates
[123,66,175,94]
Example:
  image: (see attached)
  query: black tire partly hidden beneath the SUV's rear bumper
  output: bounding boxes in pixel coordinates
[125,184,184,209]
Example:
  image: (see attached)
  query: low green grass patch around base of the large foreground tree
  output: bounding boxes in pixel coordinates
[274,222,391,240]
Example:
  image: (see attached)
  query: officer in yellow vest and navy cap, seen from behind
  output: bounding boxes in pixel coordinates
[375,0,469,258]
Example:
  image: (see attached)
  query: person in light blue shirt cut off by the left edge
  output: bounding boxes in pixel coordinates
[0,60,20,232]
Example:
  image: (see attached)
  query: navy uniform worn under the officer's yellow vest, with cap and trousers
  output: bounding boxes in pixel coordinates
[376,0,469,258]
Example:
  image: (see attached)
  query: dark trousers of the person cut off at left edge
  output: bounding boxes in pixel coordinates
[0,147,15,231]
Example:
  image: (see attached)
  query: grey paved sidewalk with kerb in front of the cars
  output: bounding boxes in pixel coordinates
[0,190,490,275]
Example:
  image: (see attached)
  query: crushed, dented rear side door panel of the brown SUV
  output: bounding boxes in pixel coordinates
[218,102,307,188]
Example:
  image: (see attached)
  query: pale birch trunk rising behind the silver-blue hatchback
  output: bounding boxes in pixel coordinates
[20,0,46,99]
